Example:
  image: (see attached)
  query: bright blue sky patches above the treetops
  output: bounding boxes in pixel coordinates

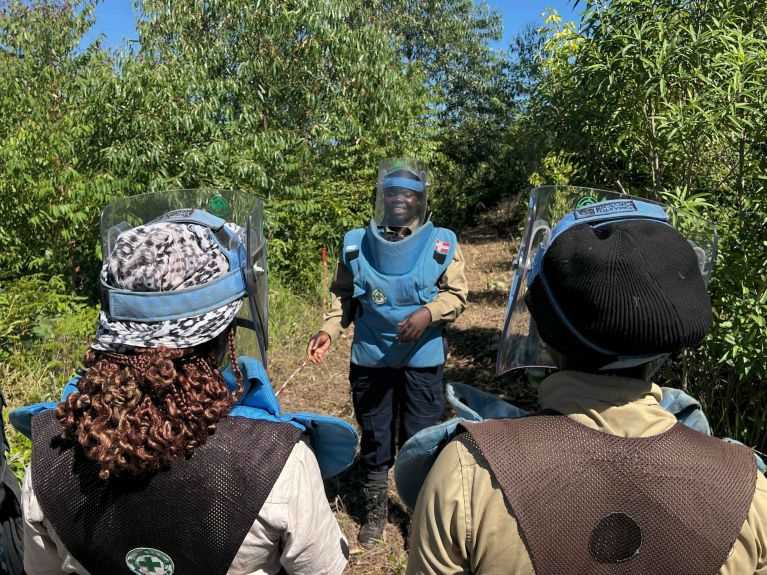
[84,0,577,48]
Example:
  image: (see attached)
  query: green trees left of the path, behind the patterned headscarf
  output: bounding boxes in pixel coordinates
[0,0,498,293]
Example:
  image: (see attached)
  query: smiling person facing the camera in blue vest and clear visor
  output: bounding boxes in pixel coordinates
[307,159,467,549]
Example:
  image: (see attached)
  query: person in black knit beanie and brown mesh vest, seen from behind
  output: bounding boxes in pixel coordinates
[407,190,767,575]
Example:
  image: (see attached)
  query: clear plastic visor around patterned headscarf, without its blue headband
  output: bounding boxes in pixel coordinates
[100,188,268,365]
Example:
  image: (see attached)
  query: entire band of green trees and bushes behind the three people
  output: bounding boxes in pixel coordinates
[0,0,767,446]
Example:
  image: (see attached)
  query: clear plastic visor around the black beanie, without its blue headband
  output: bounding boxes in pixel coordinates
[495,186,717,375]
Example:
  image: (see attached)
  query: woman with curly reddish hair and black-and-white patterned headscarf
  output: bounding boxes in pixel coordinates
[22,210,348,575]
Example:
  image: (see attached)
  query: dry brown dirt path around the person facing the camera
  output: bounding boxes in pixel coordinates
[270,206,536,575]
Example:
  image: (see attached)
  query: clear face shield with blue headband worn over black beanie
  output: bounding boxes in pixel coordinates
[496,186,717,375]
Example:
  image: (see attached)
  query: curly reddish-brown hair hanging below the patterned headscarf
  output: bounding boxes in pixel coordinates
[55,328,242,479]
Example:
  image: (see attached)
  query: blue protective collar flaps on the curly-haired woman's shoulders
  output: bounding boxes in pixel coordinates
[8,356,357,479]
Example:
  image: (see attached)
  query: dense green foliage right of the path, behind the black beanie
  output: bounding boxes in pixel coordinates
[527,0,767,446]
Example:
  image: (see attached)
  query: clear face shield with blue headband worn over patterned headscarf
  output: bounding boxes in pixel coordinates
[100,189,268,365]
